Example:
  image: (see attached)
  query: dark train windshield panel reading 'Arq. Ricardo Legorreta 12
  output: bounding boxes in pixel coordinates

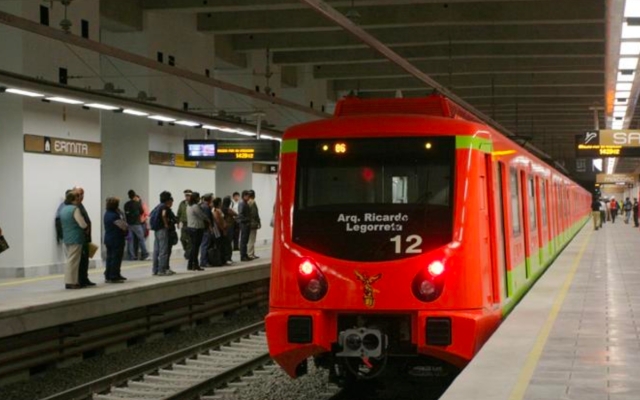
[293,136,455,261]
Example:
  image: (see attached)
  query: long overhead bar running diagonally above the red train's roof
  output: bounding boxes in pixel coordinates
[300,0,568,173]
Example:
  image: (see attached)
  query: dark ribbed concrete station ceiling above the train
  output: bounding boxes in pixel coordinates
[143,0,606,167]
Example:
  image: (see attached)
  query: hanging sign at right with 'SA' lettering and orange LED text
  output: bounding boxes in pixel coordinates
[576,129,640,158]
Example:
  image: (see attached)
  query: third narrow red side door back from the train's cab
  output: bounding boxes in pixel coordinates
[520,171,539,279]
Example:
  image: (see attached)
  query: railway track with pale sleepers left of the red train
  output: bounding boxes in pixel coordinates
[44,322,270,400]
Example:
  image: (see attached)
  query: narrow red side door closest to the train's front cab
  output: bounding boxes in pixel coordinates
[486,155,510,302]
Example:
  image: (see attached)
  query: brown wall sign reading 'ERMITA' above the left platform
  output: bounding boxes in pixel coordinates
[24,135,102,158]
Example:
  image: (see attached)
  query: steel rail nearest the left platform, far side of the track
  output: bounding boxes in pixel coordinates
[42,322,268,400]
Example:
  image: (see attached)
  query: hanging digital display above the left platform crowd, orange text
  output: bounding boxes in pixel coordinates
[184,140,280,161]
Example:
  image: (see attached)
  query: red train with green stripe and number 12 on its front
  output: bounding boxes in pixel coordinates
[266,95,591,384]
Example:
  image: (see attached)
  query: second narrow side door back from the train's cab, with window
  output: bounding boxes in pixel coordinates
[507,167,526,294]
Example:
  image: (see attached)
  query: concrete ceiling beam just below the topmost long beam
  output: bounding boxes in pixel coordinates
[230,23,604,52]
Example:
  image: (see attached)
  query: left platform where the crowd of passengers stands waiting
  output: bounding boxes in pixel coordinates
[0,246,271,338]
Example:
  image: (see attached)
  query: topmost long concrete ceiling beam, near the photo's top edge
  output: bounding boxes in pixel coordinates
[198,0,604,34]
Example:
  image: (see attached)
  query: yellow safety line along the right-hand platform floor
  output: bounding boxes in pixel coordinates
[509,231,593,400]
